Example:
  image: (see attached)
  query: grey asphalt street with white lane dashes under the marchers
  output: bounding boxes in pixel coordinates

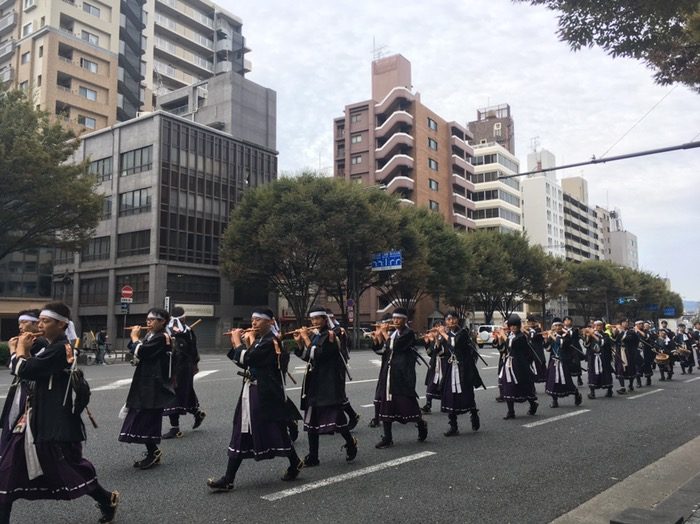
[0,348,700,524]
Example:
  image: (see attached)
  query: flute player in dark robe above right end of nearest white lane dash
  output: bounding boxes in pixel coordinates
[372,307,428,449]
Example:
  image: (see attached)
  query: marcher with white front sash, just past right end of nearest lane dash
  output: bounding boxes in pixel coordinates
[438,311,484,437]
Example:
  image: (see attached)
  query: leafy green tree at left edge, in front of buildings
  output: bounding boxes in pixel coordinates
[0,90,104,259]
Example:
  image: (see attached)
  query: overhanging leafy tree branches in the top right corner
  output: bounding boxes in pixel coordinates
[513,0,700,91]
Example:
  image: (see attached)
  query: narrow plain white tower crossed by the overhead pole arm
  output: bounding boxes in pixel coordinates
[520,149,566,258]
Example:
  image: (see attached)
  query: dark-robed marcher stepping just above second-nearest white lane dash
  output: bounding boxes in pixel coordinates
[545,318,583,408]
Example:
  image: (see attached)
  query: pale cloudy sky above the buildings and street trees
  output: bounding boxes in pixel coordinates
[217,0,700,300]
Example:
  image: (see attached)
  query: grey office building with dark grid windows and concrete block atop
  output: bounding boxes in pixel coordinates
[54,69,277,348]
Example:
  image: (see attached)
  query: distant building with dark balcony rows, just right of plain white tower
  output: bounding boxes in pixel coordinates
[561,176,604,262]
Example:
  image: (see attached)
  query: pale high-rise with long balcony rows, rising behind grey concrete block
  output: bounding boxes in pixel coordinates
[143,0,251,101]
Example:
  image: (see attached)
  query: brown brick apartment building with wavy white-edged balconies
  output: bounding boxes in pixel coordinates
[333,55,475,230]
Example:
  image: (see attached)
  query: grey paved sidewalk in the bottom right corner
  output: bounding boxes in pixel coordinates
[551,437,700,524]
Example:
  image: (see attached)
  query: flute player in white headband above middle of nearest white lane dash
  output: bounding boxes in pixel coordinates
[294,307,357,467]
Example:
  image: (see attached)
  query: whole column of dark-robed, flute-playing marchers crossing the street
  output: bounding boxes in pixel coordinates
[0,302,700,524]
